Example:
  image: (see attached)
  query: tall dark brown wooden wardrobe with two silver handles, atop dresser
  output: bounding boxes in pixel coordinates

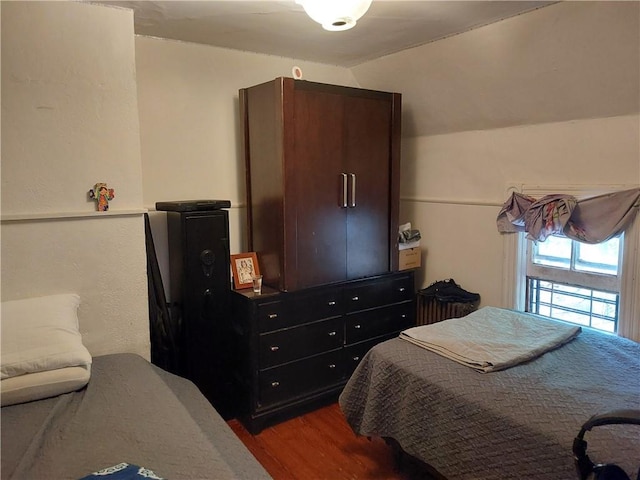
[240,78,401,291]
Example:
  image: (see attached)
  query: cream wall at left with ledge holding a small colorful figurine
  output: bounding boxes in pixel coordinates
[1,2,149,358]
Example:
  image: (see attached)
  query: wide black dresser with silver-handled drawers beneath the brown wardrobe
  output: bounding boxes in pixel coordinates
[232,271,415,433]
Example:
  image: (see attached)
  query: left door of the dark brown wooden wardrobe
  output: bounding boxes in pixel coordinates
[292,89,347,288]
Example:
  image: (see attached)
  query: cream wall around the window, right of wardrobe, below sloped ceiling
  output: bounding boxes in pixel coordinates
[401,115,640,306]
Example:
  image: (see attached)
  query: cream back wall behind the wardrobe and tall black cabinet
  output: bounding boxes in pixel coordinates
[136,36,357,295]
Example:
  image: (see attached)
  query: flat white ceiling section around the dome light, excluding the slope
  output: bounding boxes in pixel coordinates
[89,0,556,67]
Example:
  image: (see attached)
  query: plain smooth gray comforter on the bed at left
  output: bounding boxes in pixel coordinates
[1,354,270,479]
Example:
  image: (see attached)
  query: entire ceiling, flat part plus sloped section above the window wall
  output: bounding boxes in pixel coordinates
[91,0,640,136]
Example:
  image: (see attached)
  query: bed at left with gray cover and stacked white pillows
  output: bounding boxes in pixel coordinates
[0,295,271,480]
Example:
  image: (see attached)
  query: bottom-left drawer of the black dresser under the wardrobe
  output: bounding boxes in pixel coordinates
[258,350,344,407]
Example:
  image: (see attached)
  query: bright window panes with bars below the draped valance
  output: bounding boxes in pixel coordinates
[525,235,624,333]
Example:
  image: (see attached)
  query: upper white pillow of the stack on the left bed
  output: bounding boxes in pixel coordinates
[0,294,91,380]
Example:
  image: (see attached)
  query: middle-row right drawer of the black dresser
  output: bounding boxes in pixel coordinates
[345,302,415,345]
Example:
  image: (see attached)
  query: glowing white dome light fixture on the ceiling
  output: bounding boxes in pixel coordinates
[296,0,372,32]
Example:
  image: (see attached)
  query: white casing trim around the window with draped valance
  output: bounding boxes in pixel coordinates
[502,183,640,342]
